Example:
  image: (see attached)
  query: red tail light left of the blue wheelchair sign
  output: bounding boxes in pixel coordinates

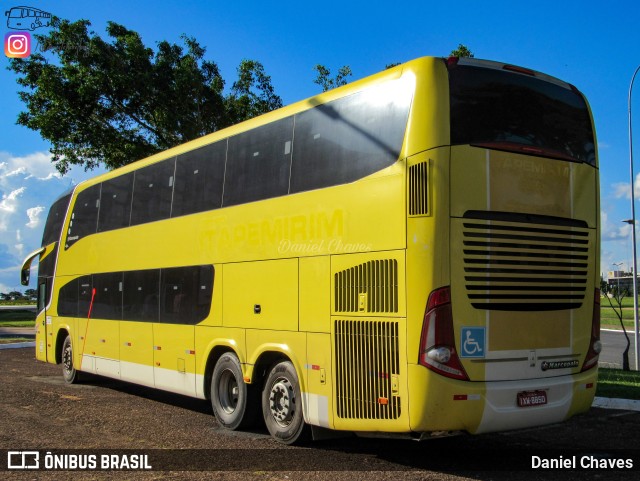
[418,287,469,381]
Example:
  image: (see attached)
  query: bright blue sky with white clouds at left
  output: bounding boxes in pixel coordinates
[0,0,640,292]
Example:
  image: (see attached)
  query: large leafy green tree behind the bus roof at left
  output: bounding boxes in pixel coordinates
[9,19,282,174]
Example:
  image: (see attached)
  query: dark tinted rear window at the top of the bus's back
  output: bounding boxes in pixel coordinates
[449,65,596,166]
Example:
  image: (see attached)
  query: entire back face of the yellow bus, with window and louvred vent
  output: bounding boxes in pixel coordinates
[412,58,600,433]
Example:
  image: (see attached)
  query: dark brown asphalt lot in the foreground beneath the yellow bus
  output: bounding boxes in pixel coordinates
[0,348,640,481]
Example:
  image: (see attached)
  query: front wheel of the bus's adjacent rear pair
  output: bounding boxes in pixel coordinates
[211,352,258,430]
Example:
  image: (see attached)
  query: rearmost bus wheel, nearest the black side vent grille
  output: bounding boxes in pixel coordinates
[262,361,311,444]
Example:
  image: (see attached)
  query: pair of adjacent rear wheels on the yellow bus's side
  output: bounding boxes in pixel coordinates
[211,352,309,444]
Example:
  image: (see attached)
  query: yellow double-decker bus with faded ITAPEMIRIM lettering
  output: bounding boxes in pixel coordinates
[22,58,600,443]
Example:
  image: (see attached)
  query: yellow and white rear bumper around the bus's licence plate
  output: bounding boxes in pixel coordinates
[409,365,597,434]
